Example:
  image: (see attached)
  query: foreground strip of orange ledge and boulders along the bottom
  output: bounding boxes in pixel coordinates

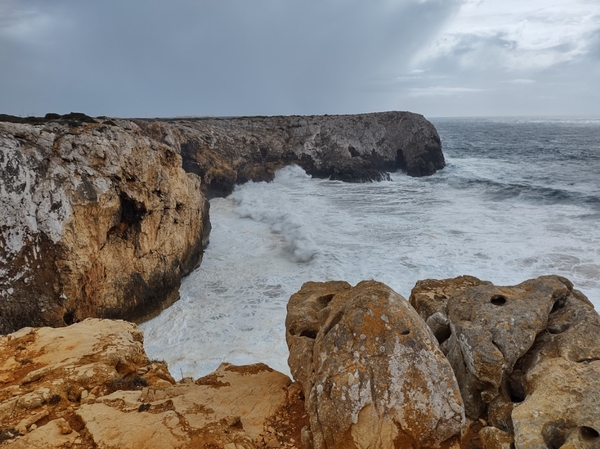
[0,276,600,449]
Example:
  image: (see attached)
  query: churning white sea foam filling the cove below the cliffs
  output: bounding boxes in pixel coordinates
[142,161,600,377]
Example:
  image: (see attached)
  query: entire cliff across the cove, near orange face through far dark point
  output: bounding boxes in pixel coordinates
[0,112,444,334]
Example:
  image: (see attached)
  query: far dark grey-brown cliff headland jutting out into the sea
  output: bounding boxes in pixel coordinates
[137,112,445,196]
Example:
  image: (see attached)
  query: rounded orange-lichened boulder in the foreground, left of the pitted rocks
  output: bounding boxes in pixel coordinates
[286,281,464,449]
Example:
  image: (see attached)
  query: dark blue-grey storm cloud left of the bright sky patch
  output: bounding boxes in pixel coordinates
[0,0,461,116]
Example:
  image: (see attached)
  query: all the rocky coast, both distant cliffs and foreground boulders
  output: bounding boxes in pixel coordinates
[0,112,600,449]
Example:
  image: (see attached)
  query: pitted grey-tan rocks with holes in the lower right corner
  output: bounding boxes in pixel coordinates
[410,276,600,448]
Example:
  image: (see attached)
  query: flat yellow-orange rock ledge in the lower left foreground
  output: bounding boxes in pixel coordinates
[0,319,306,449]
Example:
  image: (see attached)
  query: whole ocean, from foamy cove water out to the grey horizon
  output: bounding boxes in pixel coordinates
[141,118,600,378]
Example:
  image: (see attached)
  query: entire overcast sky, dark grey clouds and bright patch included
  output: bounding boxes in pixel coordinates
[0,0,600,117]
